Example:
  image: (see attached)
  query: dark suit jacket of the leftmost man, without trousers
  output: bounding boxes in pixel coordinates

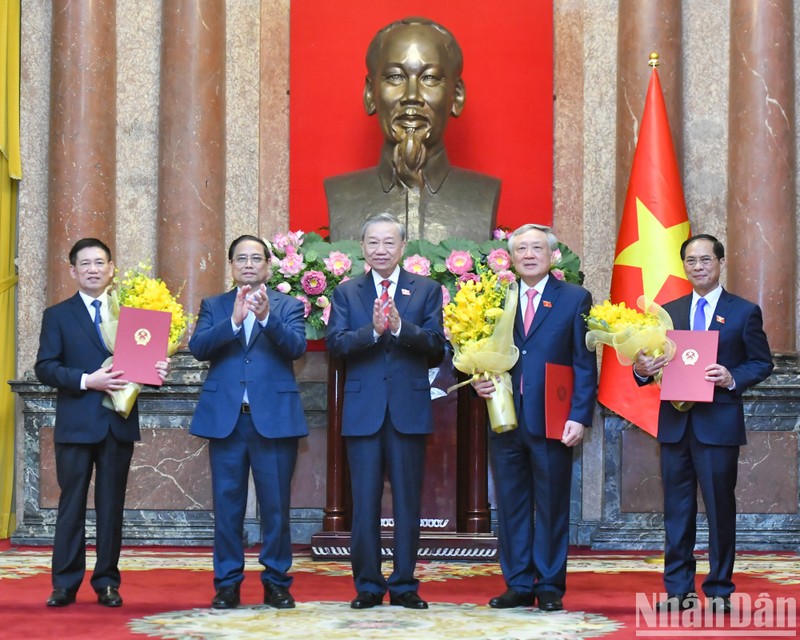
[34,293,140,444]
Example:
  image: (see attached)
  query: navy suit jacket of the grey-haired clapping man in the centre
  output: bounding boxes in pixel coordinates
[326,269,445,436]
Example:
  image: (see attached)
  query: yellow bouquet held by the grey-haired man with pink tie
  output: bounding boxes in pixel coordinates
[444,268,519,433]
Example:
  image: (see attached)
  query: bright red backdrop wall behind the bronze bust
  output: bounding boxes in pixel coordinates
[289,0,553,238]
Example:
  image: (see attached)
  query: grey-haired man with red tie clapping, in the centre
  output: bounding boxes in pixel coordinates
[327,213,445,609]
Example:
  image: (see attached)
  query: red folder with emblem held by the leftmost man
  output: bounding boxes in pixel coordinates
[112,307,172,386]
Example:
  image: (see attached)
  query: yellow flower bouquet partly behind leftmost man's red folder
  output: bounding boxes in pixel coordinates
[100,263,193,418]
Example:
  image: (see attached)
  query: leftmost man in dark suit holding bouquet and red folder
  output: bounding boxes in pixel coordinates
[35,238,168,607]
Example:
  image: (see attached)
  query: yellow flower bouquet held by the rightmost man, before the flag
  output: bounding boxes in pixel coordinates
[586,296,675,366]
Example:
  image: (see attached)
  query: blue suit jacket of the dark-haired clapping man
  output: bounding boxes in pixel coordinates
[189,289,308,438]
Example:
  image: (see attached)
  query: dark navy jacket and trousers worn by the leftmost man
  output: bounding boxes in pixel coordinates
[35,293,139,591]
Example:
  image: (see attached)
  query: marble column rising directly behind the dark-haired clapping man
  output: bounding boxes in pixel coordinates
[157,0,227,314]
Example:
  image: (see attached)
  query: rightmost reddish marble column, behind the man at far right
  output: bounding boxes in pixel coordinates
[727,0,797,352]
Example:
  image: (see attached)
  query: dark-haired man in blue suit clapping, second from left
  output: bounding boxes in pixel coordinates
[189,235,308,609]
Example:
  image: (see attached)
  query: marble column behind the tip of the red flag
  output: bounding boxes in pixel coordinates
[616,0,683,225]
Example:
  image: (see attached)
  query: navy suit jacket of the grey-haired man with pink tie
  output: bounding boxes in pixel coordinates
[511,276,597,436]
